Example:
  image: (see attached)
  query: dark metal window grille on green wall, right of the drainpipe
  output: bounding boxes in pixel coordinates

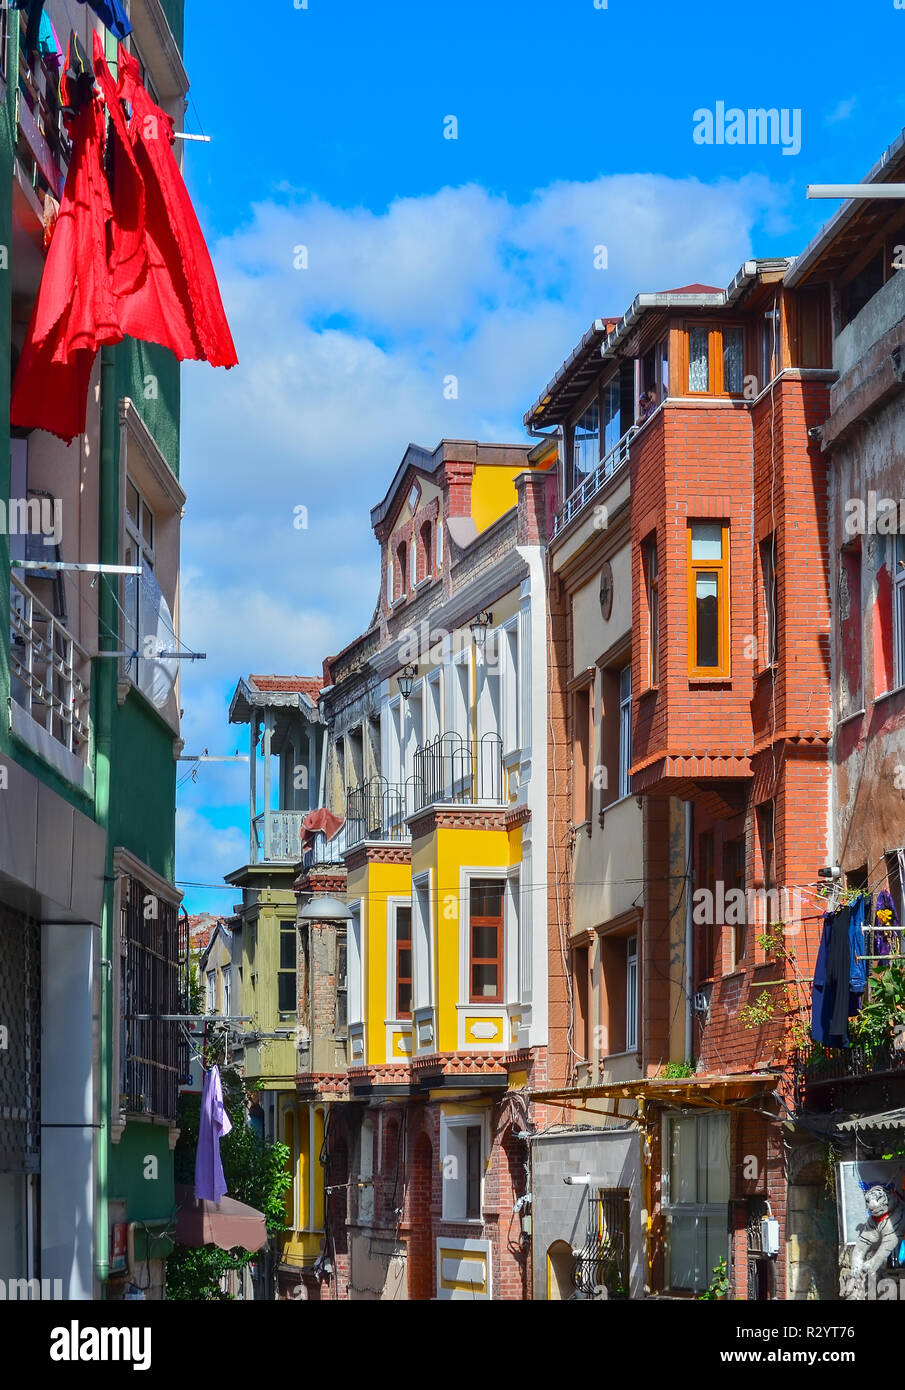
[120,876,179,1119]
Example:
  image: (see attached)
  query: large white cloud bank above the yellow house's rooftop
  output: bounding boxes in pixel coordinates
[179,174,788,906]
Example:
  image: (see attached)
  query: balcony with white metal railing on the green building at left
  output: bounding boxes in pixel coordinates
[10,574,93,794]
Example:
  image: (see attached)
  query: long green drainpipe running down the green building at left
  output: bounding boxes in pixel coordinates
[92,346,120,1297]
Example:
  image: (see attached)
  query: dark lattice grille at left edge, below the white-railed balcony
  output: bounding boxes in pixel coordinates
[0,905,40,1173]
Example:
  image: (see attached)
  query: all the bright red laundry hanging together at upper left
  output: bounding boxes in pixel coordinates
[10,32,238,443]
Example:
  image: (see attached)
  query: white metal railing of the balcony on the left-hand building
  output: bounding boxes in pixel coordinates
[10,574,92,760]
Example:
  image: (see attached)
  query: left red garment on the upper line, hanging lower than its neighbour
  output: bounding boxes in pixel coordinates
[10,88,122,443]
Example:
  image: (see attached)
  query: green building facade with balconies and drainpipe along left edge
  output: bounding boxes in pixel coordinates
[0,0,188,1298]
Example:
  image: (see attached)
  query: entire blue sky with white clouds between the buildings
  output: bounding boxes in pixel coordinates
[177,0,905,912]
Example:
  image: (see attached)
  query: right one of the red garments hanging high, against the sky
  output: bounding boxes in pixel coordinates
[113,35,238,367]
